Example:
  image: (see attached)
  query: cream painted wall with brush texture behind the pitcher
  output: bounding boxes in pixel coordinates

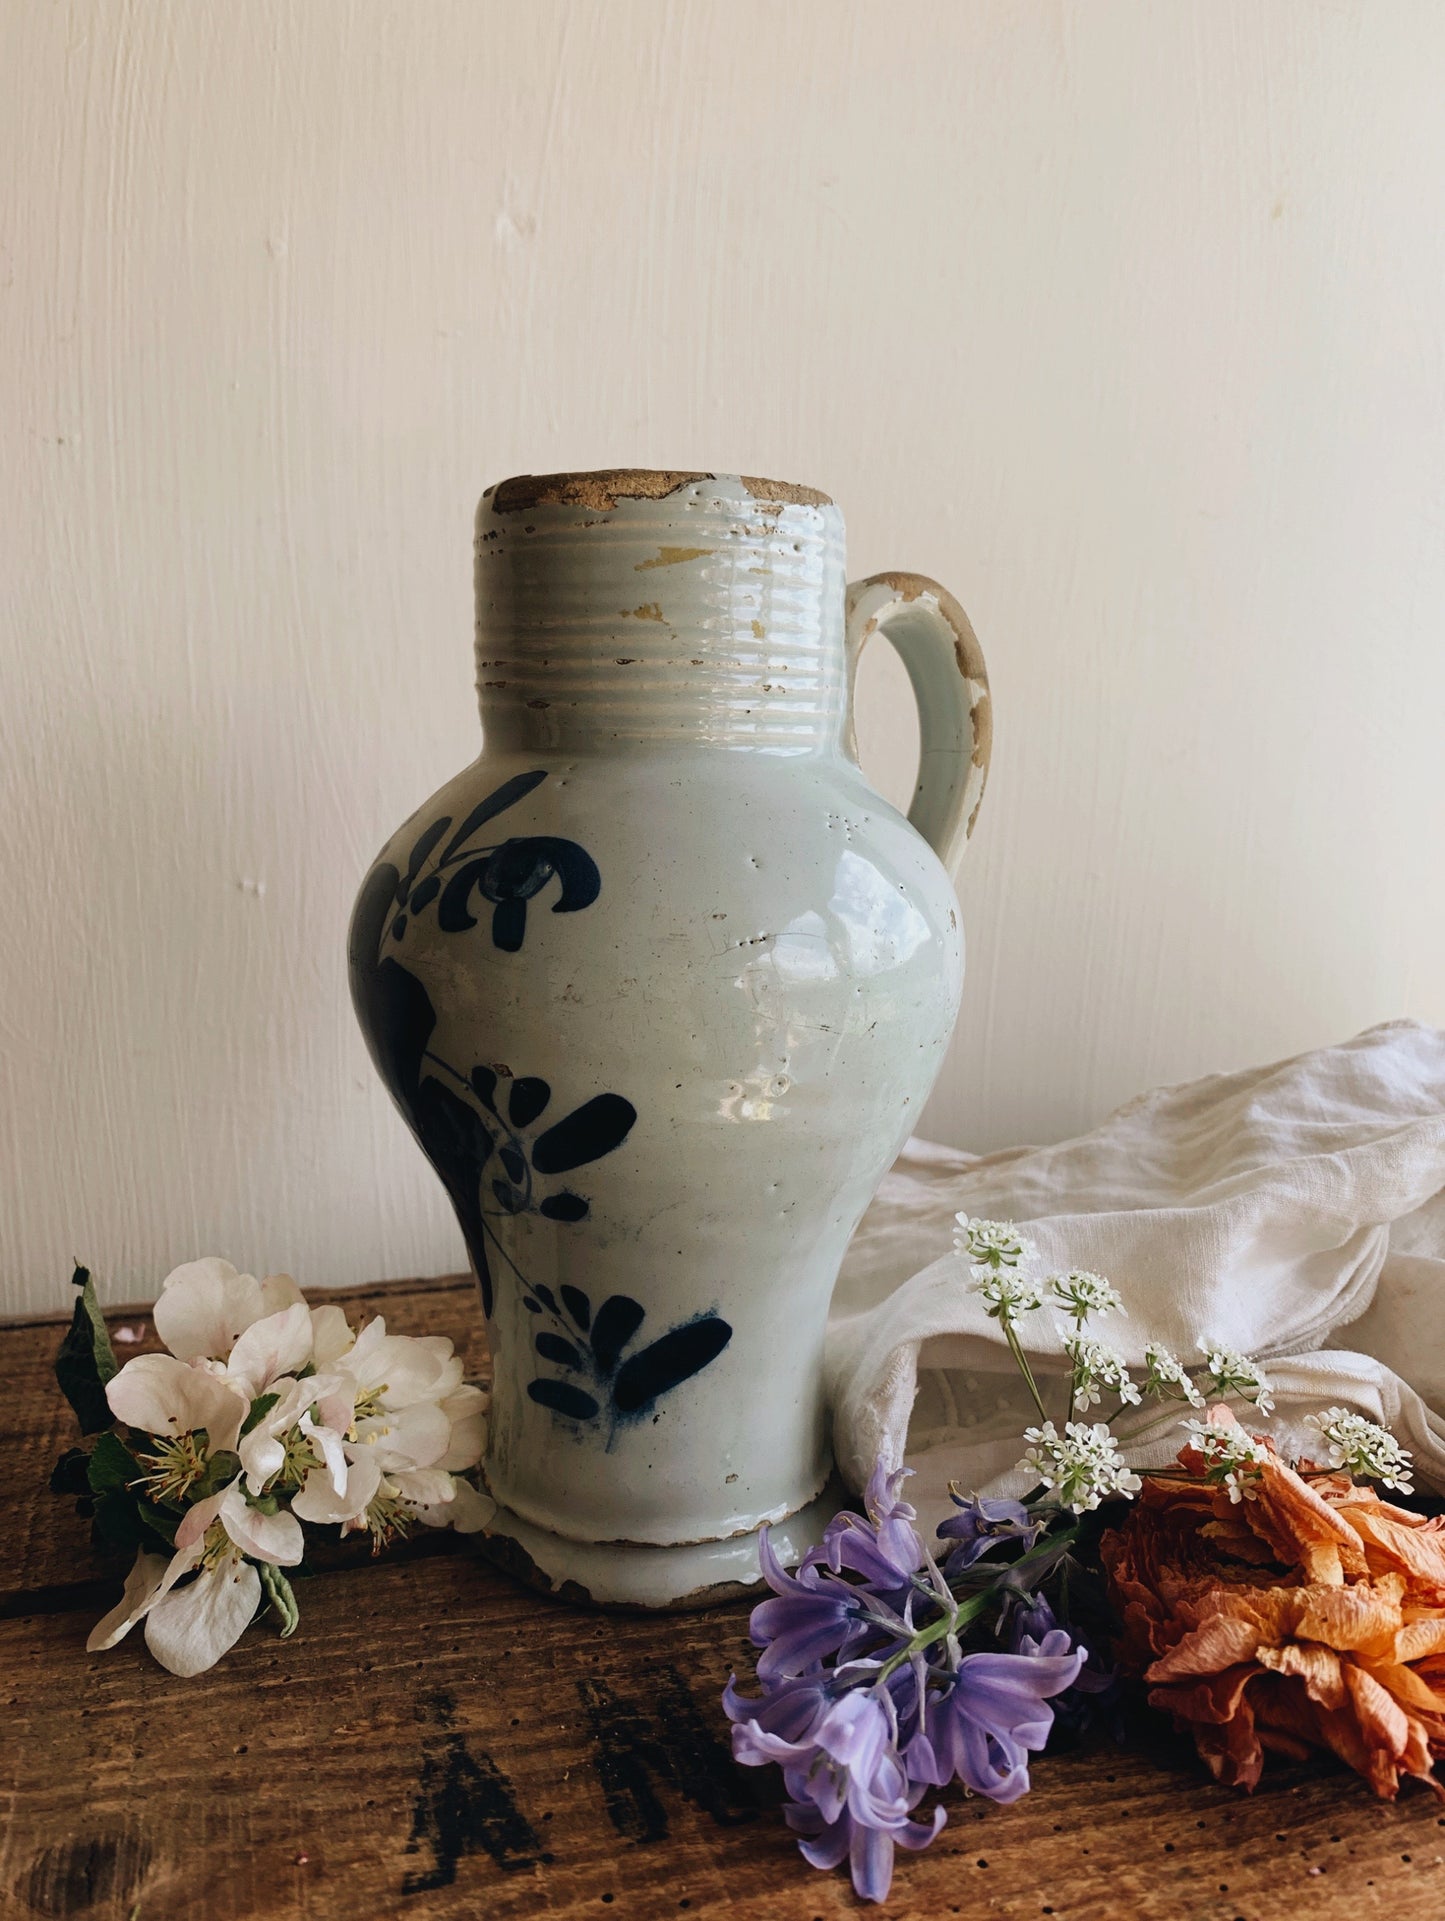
[0,0,1445,1308]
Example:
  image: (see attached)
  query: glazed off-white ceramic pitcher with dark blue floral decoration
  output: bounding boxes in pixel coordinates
[350,473,990,1606]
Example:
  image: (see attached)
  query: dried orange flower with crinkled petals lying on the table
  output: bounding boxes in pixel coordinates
[1101,1408,1445,1800]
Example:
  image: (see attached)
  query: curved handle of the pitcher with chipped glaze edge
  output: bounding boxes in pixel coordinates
[847,574,993,874]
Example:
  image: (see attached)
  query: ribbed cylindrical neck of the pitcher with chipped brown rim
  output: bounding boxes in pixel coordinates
[477,471,847,753]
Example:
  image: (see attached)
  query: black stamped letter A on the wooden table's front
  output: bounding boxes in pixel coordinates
[402,1690,551,1894]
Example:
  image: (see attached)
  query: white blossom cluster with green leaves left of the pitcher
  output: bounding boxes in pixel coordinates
[52,1258,488,1675]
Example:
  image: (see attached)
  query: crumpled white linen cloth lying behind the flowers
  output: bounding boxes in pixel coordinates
[828,1020,1445,1521]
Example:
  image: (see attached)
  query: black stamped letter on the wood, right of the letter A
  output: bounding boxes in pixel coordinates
[576,1666,759,1842]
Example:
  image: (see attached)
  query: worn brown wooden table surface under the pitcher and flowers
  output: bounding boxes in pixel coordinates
[0,1277,1445,1921]
